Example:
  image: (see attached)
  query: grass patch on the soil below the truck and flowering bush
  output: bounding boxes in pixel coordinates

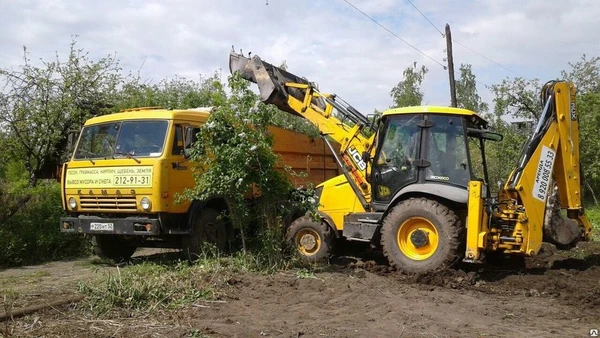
[79,244,316,315]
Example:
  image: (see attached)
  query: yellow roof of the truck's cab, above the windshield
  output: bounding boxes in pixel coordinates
[85,107,212,126]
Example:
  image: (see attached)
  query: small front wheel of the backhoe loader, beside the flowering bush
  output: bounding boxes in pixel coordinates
[286,216,335,263]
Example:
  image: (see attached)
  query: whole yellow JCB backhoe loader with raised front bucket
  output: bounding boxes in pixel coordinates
[229,52,591,273]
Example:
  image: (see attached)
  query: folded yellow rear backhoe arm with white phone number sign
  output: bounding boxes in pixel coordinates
[496,81,591,255]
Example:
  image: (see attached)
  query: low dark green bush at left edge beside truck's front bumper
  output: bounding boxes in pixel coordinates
[0,182,90,267]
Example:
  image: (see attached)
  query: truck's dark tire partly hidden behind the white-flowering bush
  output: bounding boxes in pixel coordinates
[181,208,227,262]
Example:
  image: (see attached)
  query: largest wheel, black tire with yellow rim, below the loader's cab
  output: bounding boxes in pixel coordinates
[381,198,464,273]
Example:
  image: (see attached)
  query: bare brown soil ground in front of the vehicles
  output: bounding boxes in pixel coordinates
[0,243,600,337]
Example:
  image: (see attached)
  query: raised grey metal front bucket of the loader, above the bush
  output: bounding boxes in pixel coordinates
[229,51,325,115]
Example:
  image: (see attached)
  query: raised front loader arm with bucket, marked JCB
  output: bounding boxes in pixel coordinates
[229,52,375,210]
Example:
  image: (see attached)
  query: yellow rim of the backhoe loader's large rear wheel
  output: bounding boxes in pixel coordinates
[397,217,439,261]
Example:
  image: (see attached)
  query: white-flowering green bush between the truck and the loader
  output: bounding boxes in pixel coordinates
[185,74,314,264]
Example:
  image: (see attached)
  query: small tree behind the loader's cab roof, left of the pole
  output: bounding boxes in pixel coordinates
[390,62,429,107]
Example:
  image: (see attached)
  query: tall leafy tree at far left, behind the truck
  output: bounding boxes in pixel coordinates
[0,41,121,223]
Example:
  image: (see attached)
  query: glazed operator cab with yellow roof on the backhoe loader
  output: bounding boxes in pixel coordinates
[371,106,502,209]
